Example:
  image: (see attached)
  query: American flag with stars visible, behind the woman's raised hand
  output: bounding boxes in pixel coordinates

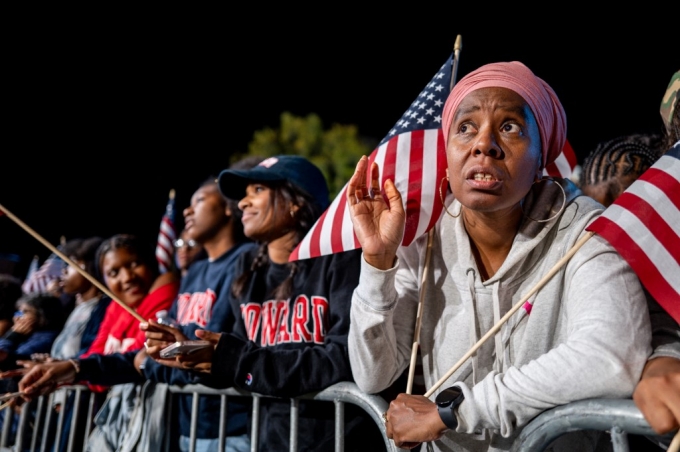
[289,53,577,262]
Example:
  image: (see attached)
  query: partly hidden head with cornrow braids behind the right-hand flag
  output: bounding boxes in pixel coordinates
[580,134,663,206]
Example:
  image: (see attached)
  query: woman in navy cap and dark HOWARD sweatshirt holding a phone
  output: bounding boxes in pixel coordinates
[147,155,384,451]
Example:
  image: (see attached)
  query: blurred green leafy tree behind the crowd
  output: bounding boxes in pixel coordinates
[232,112,377,200]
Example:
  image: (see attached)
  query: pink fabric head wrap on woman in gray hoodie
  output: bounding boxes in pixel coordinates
[442,61,567,168]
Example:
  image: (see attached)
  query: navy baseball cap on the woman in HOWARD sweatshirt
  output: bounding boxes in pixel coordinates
[217,155,329,210]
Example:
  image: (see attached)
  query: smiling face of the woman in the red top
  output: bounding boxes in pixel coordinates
[102,248,154,307]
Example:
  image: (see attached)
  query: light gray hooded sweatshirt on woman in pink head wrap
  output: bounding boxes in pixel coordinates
[349,180,652,451]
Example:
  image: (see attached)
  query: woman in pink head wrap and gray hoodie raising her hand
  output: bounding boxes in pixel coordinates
[347,62,651,451]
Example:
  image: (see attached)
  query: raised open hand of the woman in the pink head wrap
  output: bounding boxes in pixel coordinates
[347,156,406,270]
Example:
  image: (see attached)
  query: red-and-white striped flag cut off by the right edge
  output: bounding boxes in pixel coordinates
[586,141,680,323]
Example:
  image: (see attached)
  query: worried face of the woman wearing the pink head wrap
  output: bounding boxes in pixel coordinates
[446,88,541,212]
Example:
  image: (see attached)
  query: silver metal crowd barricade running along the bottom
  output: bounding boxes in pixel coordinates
[0,382,673,452]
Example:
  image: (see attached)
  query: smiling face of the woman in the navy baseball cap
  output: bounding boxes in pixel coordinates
[238,183,297,242]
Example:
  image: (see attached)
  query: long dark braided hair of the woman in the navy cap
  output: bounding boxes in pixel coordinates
[232,181,323,300]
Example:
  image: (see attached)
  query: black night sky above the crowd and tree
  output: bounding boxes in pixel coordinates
[0,7,680,276]
